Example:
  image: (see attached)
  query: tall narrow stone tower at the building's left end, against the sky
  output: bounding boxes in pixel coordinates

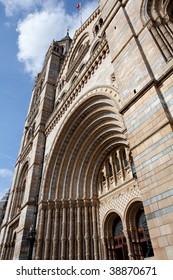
[1,33,71,259]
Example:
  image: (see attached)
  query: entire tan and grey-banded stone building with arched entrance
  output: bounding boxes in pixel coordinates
[0,0,173,260]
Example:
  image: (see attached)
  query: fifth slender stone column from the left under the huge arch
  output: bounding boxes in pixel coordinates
[69,204,75,260]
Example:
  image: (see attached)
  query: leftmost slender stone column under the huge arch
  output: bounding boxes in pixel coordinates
[35,209,45,260]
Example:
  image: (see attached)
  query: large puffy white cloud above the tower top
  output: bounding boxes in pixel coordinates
[16,0,98,76]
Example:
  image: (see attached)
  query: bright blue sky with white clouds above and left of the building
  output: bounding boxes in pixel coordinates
[0,0,98,198]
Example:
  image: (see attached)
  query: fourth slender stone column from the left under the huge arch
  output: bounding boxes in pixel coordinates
[61,203,67,260]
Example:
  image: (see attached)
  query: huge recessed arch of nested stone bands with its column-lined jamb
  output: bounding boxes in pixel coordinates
[36,88,128,260]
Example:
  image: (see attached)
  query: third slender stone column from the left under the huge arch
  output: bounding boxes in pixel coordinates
[52,203,60,260]
